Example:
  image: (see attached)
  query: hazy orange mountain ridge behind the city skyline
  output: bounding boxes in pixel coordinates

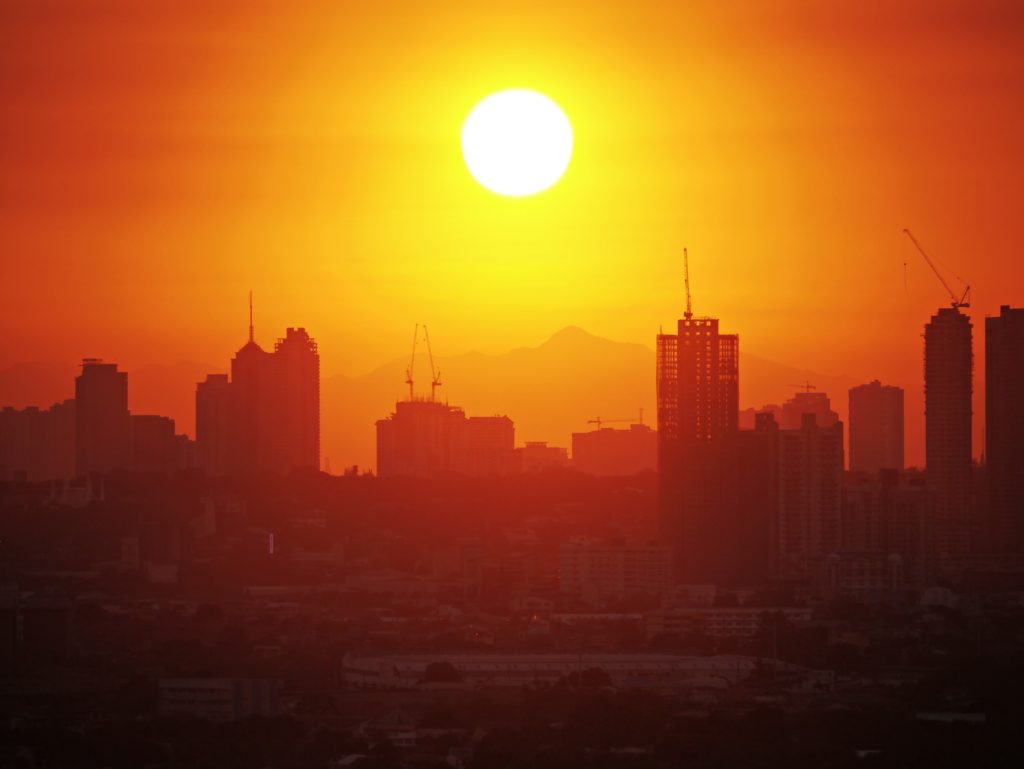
[0,326,861,472]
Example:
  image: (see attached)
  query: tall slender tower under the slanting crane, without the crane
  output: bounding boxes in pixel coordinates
[925,307,974,558]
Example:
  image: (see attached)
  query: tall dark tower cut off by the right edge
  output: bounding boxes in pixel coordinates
[985,305,1024,553]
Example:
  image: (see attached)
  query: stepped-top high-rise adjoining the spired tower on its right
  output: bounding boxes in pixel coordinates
[272,328,319,472]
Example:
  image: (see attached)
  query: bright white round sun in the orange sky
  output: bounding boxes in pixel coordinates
[462,89,572,198]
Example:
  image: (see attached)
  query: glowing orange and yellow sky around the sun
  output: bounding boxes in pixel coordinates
[0,0,1024,461]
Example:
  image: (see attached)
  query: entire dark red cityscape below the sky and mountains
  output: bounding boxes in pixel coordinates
[0,284,1024,769]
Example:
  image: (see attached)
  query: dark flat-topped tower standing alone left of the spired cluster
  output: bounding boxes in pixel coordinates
[75,358,131,475]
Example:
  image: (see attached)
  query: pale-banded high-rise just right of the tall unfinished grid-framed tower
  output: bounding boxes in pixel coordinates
[778,414,844,581]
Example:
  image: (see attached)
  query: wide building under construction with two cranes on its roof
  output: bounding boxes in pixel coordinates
[377,326,516,478]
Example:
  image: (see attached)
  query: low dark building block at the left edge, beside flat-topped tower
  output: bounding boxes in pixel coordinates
[0,399,75,481]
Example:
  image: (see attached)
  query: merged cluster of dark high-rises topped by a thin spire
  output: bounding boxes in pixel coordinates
[196,298,321,475]
